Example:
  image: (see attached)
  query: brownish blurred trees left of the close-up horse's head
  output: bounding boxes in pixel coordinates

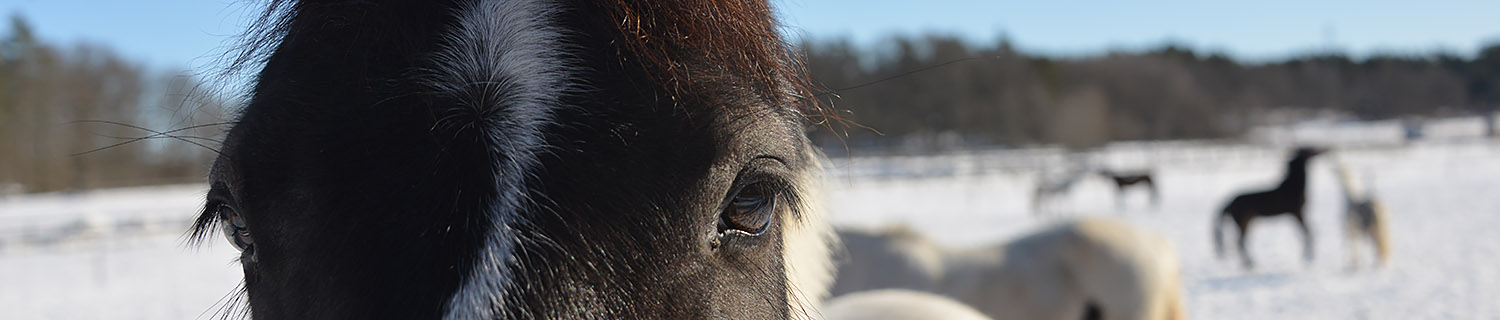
[0,17,224,195]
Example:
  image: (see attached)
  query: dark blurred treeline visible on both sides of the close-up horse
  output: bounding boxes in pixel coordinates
[0,17,1500,190]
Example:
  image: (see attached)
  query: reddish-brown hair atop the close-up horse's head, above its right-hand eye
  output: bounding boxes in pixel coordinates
[605,0,830,122]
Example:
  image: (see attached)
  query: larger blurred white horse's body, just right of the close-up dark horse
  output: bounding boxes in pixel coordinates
[831,218,1185,320]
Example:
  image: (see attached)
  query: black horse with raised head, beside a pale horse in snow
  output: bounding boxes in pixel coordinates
[1214,147,1325,267]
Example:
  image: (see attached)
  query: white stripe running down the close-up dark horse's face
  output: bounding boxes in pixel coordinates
[429,0,575,318]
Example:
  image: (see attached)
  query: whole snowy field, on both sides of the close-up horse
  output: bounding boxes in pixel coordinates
[0,118,1500,318]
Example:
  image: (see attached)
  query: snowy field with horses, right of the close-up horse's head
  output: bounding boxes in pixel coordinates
[828,141,1500,318]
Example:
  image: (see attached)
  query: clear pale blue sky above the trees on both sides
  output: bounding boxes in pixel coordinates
[0,0,1500,69]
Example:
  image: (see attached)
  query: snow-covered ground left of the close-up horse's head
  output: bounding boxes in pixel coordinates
[0,185,240,320]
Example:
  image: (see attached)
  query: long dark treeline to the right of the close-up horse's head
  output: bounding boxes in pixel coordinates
[801,36,1500,149]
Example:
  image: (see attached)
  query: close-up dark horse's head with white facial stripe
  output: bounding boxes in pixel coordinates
[195,0,831,318]
